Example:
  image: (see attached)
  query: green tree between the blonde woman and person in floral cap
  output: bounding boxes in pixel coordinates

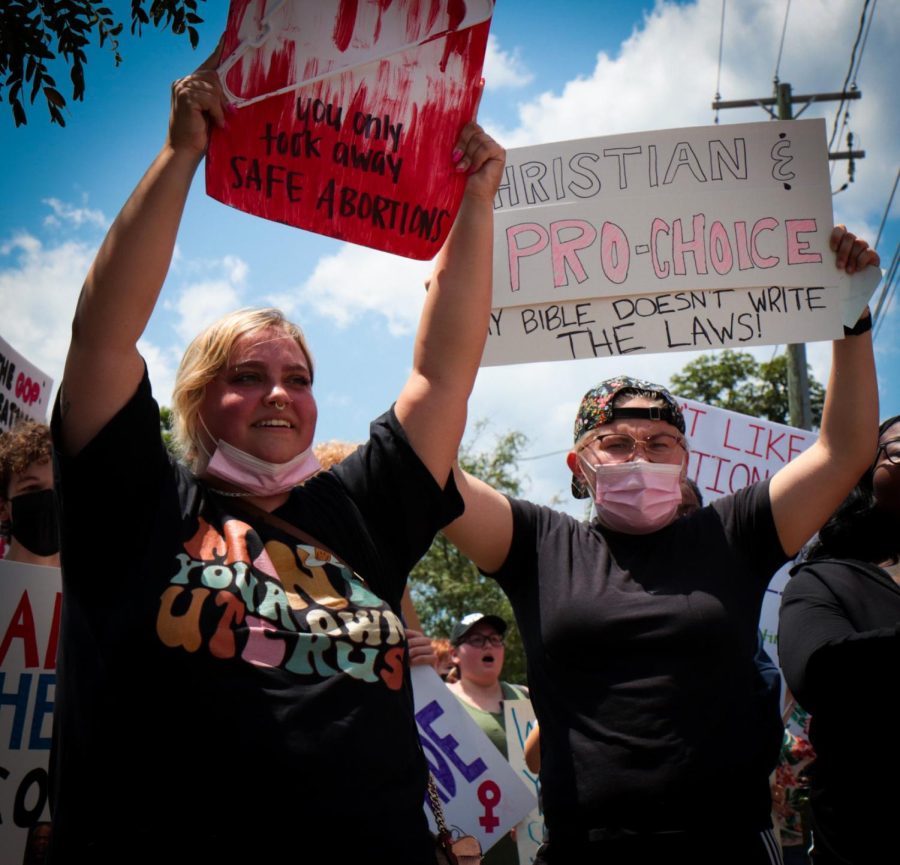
[410,421,528,682]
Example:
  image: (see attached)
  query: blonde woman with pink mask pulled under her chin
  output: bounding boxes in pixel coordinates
[52,47,504,865]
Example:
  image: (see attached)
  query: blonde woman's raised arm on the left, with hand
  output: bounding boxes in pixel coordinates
[60,48,225,454]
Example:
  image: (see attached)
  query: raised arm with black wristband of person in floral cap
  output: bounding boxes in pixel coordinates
[769,225,880,556]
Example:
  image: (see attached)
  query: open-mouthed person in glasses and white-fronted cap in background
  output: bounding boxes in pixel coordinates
[447,613,528,865]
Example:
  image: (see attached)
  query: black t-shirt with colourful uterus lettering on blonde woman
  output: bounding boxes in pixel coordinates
[51,376,462,865]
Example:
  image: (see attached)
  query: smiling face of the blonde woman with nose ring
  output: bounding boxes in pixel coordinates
[200,328,317,463]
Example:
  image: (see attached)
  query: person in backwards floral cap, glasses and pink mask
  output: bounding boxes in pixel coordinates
[444,226,879,865]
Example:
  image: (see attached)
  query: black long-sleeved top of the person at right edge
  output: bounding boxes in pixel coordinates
[778,559,900,865]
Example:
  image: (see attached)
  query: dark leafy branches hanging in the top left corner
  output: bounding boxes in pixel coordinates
[0,0,203,126]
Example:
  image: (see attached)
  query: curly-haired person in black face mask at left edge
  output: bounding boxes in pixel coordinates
[0,421,59,568]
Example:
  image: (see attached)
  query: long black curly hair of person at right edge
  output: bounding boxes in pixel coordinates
[806,415,900,562]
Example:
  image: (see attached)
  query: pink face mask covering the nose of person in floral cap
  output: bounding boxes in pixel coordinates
[591,462,681,535]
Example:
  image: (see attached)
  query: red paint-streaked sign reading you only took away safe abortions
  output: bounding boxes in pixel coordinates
[206,0,493,259]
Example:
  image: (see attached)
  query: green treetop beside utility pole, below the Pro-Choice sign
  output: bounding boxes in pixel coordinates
[670,349,825,427]
